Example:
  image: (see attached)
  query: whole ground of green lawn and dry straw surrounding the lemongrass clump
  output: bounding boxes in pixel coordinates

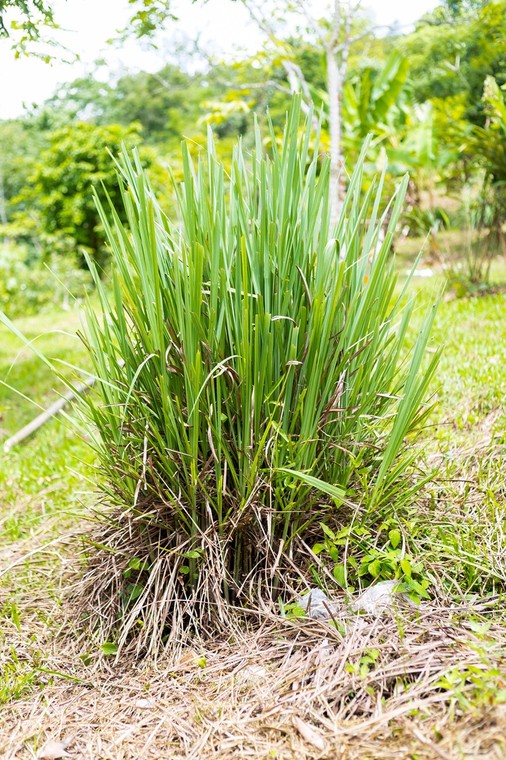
[0,256,506,760]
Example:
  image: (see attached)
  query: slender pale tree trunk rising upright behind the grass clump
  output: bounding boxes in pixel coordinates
[326,47,344,228]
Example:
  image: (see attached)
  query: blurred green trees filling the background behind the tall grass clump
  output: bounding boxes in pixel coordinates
[0,0,506,270]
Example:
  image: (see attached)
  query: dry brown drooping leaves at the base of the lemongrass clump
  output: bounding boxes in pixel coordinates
[72,498,360,656]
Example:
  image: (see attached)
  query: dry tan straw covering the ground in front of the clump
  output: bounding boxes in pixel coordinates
[0,584,506,760]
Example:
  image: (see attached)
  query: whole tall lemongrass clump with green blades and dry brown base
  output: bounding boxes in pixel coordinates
[75,99,436,651]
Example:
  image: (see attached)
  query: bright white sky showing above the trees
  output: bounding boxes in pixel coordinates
[0,0,438,119]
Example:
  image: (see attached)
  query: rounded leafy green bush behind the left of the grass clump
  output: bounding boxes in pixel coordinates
[13,122,150,263]
